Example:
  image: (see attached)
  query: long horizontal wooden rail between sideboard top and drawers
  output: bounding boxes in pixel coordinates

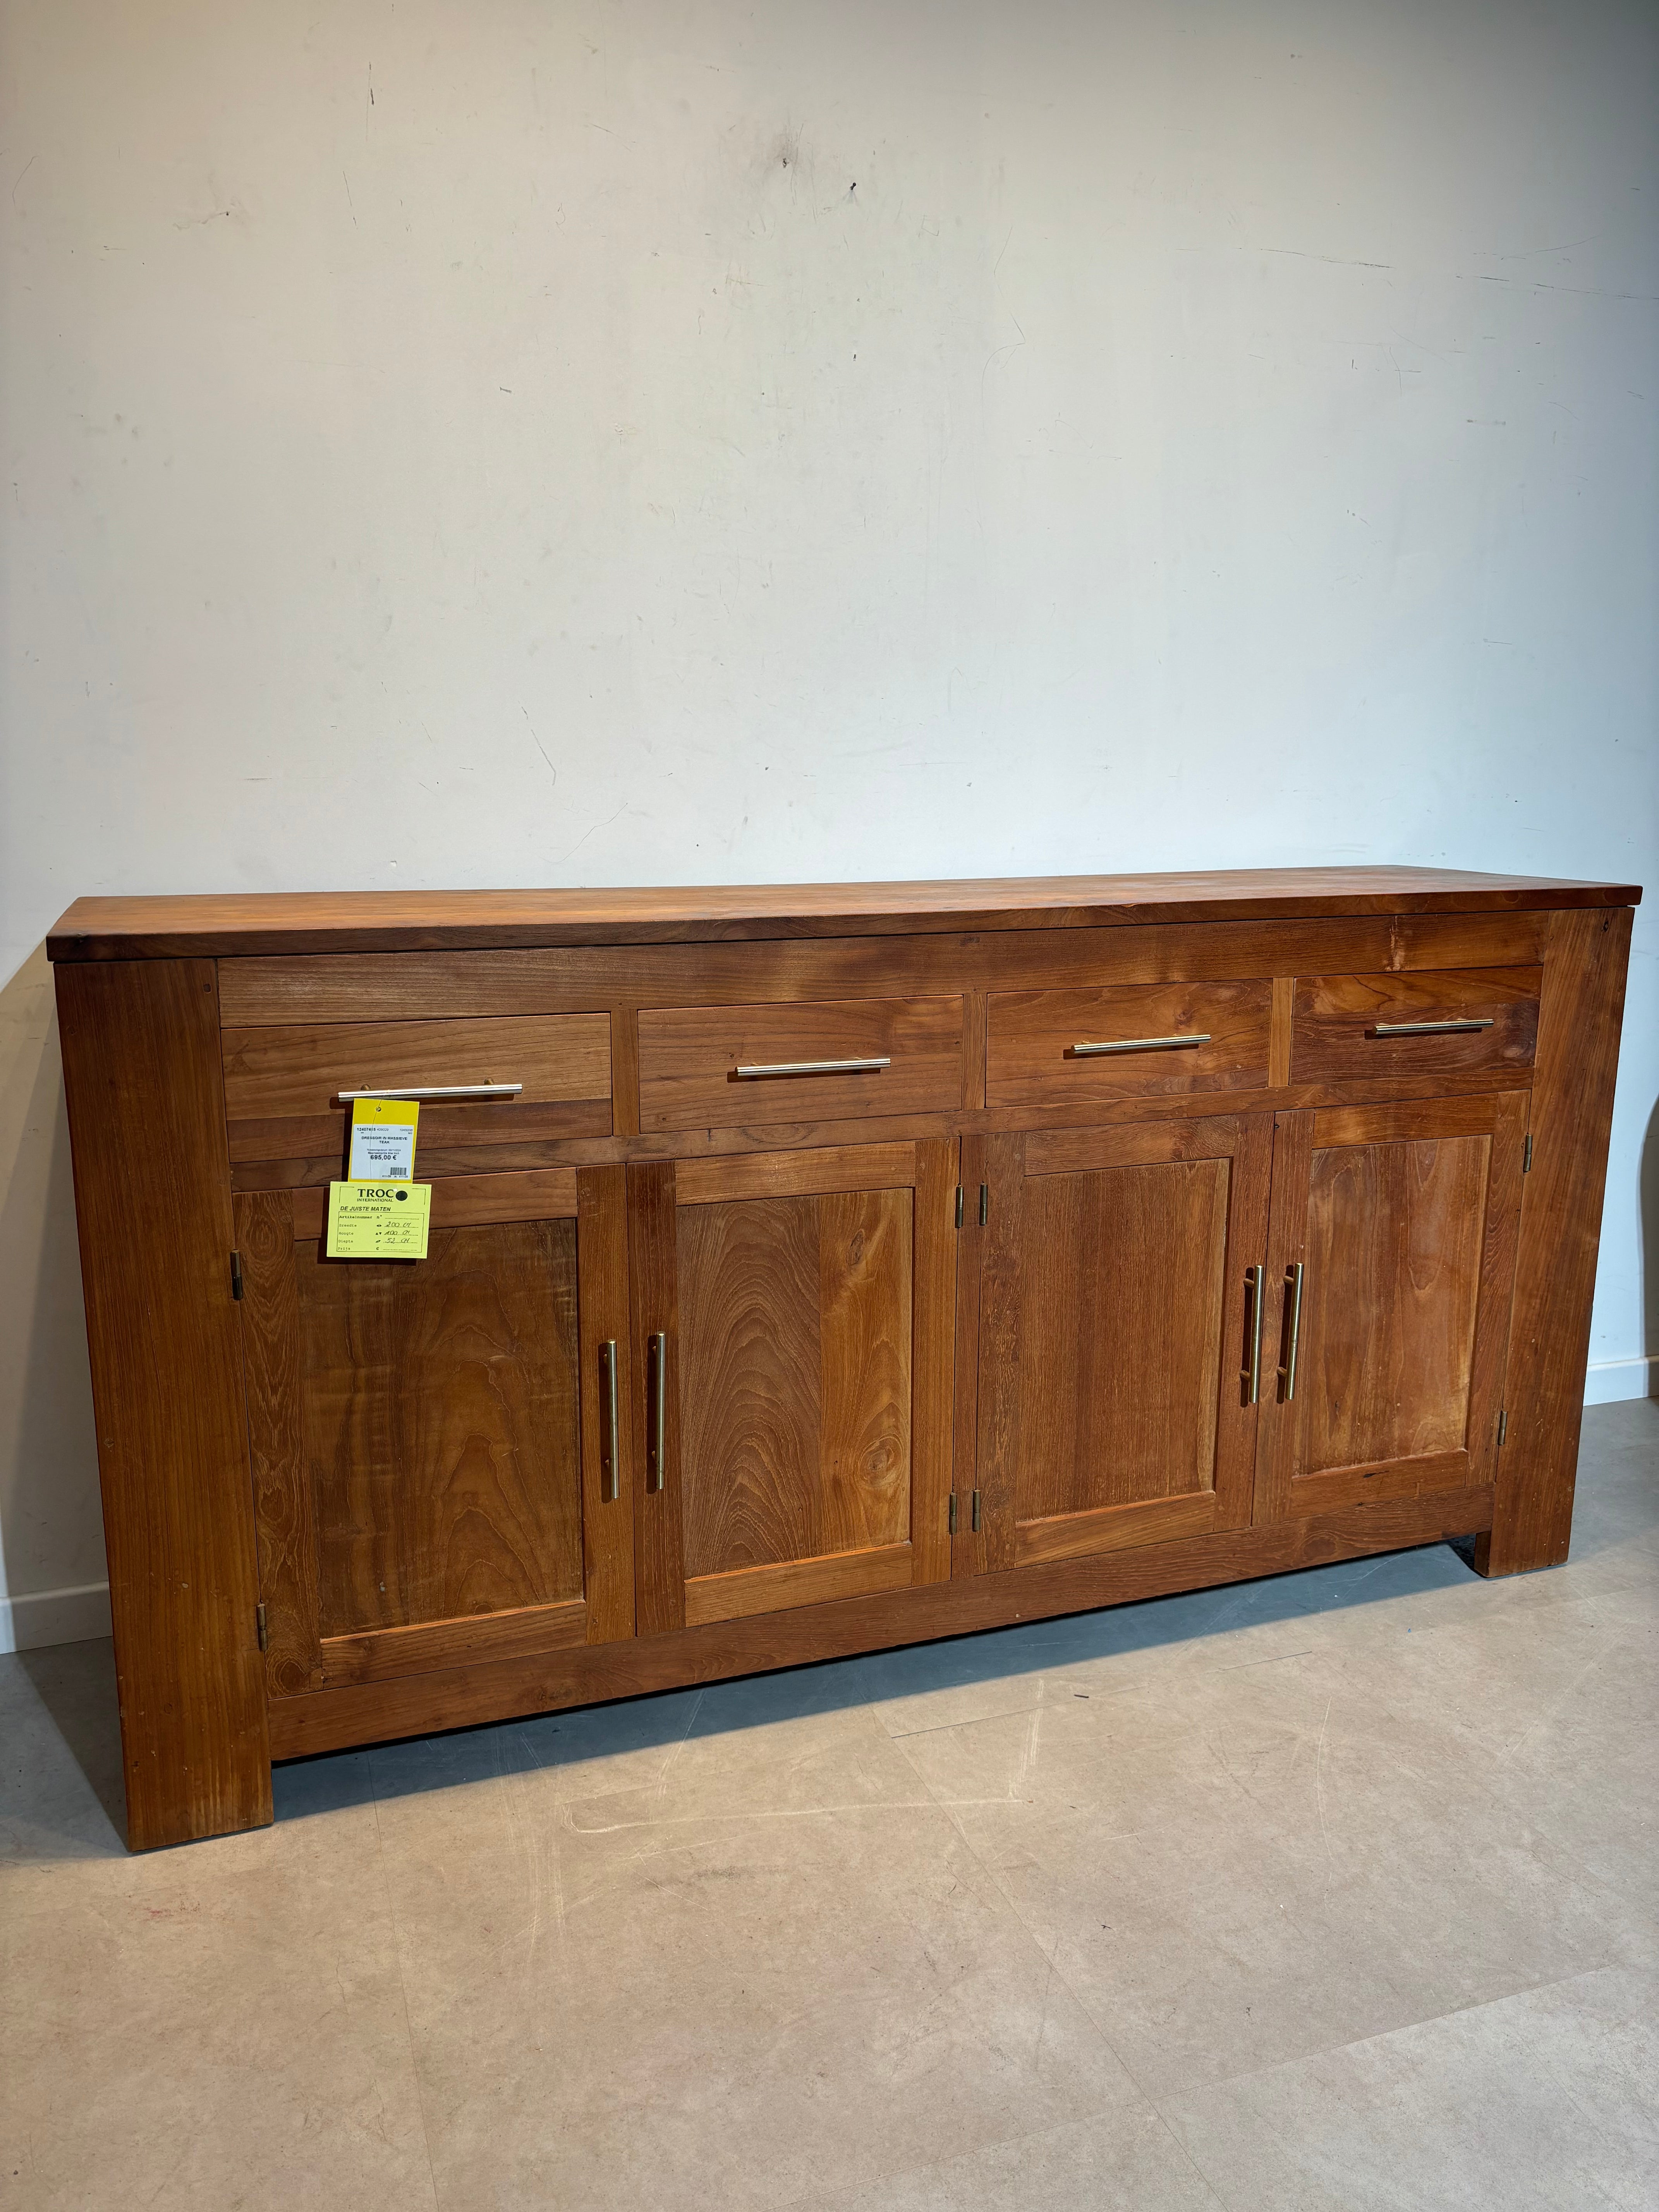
[219,914,1551,1026]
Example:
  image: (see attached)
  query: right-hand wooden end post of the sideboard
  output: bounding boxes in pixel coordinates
[1475,907,1632,1575]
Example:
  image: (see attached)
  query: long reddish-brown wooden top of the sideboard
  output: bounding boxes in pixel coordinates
[46,867,1641,960]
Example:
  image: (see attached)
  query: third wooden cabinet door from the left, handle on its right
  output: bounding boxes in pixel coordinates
[958,1115,1272,1568]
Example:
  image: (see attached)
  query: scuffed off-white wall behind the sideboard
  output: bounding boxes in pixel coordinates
[0,0,1659,1641]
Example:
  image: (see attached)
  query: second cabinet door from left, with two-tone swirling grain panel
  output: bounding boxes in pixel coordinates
[628,1141,956,1632]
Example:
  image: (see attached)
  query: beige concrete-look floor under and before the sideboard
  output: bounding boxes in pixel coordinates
[0,1405,1659,2212]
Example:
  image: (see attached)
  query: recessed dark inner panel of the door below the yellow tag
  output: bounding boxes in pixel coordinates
[294,1221,582,1637]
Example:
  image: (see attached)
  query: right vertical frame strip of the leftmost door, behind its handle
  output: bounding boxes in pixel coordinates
[575,1168,644,1644]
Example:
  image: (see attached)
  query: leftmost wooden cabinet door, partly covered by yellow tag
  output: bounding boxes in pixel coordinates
[237,1168,633,1697]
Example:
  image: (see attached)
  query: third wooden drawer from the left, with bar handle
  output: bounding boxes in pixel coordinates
[984,980,1272,1106]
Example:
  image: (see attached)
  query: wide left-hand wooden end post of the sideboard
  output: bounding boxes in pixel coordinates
[58,960,270,1851]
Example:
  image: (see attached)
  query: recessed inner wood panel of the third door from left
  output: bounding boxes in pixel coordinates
[1015,1159,1230,1522]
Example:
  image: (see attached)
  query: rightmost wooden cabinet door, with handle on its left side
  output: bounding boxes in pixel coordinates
[1256,1091,1526,1520]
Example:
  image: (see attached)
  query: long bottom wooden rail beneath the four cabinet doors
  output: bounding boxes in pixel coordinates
[270,1484,1493,1759]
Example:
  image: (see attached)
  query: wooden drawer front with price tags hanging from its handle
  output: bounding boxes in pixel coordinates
[223,1013,611,1159]
